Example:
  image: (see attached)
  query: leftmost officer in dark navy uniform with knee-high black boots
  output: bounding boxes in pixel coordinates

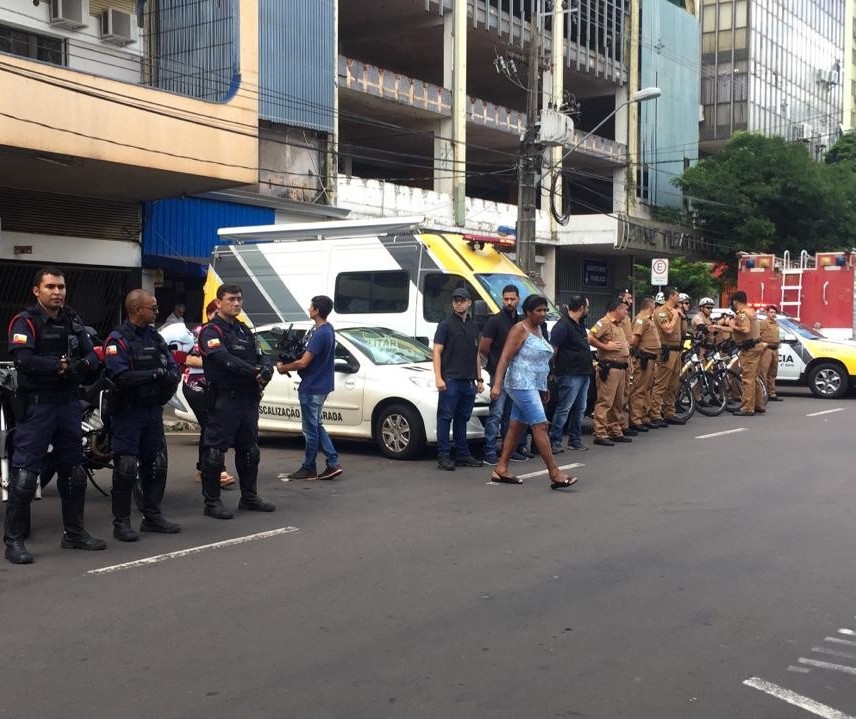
[3,267,107,564]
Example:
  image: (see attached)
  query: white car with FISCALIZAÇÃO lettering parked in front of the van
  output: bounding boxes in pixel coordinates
[176,321,490,459]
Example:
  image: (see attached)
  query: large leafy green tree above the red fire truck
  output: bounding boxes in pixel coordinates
[675,133,856,268]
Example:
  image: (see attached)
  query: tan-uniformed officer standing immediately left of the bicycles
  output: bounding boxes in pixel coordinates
[651,287,686,427]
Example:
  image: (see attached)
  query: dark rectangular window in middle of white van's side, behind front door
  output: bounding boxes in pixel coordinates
[333,270,410,315]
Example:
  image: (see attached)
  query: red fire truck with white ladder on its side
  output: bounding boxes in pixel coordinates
[737,250,856,339]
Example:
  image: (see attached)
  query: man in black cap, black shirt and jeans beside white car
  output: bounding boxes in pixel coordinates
[434,287,484,471]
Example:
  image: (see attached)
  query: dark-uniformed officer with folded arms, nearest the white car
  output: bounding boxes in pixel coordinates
[198,285,276,519]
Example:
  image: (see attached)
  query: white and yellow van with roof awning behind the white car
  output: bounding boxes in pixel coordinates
[205,217,559,345]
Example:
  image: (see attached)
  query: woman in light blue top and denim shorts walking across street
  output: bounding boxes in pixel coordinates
[490,295,577,489]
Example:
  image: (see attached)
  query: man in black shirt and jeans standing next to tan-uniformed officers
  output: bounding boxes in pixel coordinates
[550,295,592,454]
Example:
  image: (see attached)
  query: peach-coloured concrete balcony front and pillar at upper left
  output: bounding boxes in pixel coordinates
[0,0,258,201]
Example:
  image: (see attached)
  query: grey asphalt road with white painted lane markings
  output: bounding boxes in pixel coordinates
[0,390,856,719]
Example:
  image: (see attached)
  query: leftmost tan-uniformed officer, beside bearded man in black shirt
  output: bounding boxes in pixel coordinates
[589,300,633,447]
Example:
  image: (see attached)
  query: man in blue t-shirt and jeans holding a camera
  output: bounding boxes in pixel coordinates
[276,295,343,479]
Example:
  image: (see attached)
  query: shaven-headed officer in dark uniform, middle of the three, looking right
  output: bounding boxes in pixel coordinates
[104,290,181,542]
